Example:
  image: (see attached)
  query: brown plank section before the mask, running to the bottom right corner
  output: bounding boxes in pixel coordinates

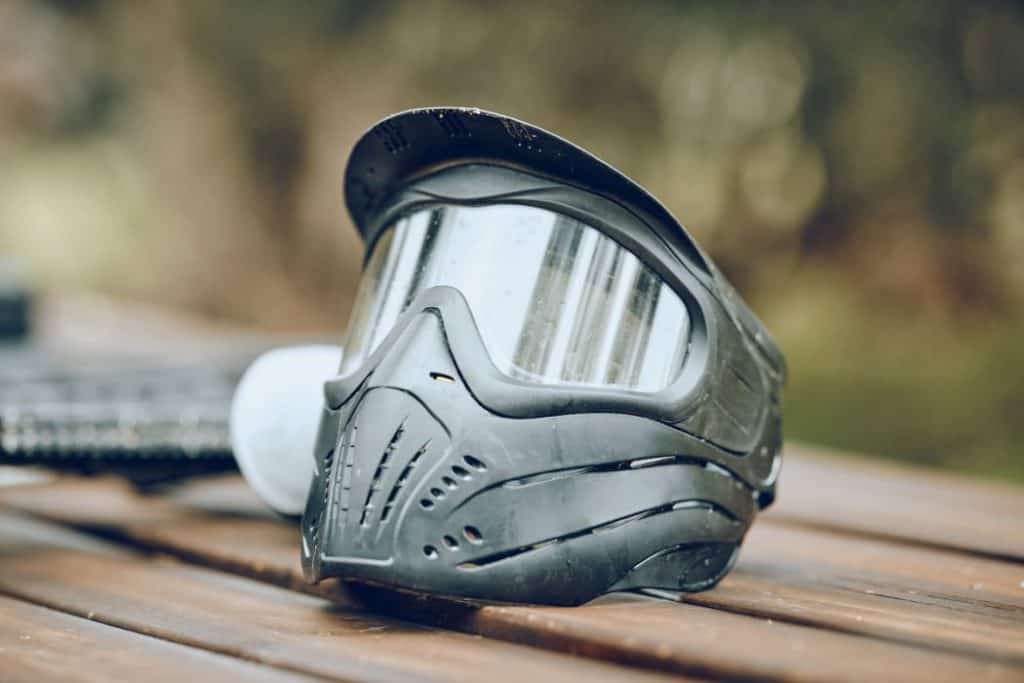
[460,595,1022,681]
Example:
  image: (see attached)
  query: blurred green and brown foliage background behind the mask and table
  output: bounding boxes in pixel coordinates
[0,0,1024,481]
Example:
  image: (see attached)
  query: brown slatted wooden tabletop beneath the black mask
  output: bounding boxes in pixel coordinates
[0,447,1024,683]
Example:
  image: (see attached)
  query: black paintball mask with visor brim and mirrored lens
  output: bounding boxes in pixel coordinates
[302,109,784,604]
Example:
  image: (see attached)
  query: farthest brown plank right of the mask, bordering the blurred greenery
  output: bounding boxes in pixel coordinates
[765,445,1024,562]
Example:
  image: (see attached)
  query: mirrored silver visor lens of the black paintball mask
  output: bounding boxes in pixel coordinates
[342,205,690,391]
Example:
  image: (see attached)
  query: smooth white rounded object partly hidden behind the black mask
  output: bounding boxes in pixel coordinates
[230,345,342,515]
